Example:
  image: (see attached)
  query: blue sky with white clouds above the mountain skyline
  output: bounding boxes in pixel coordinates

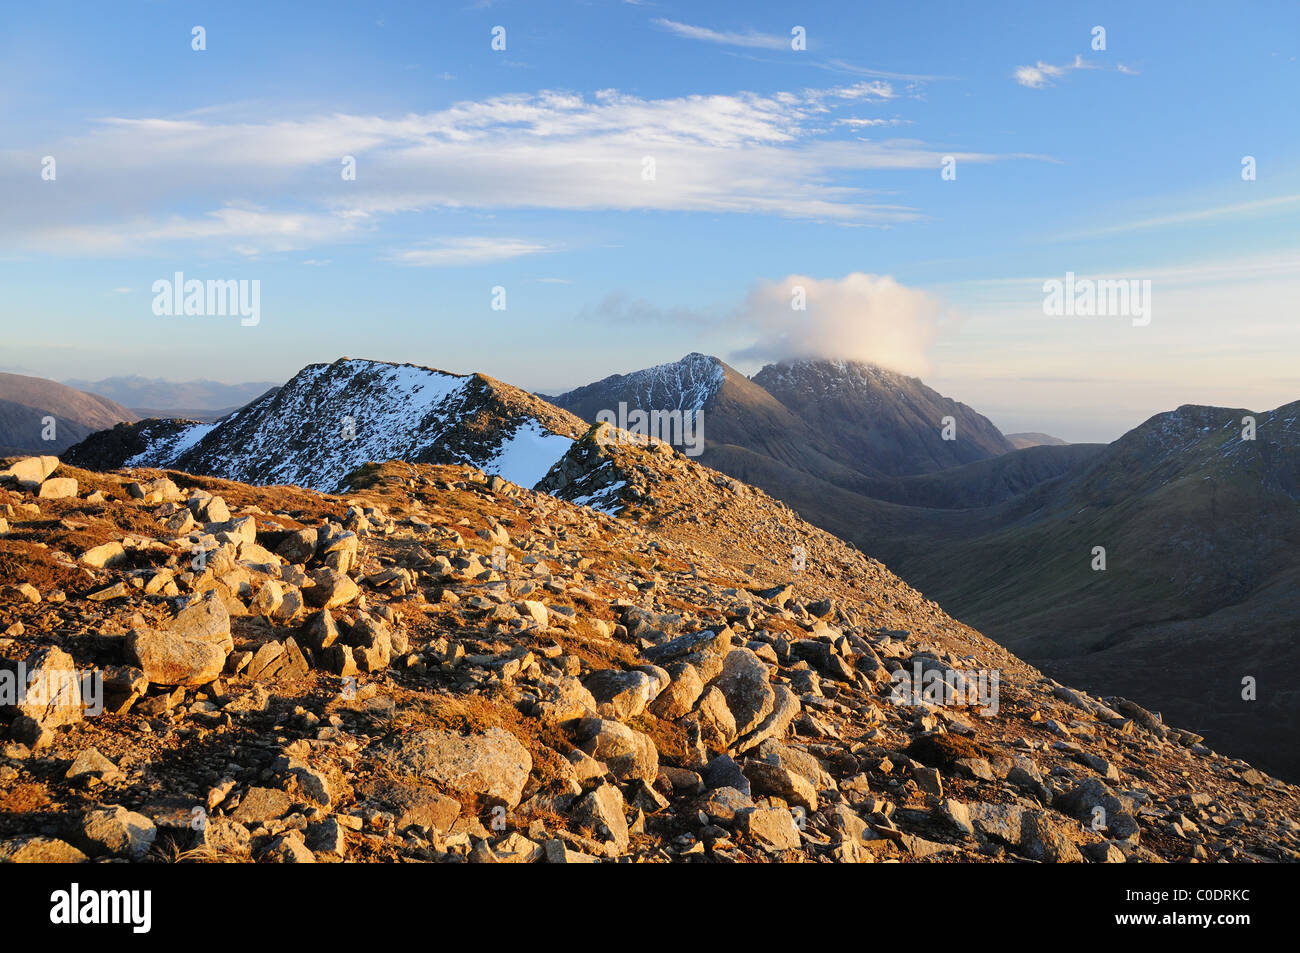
[0,3,1300,439]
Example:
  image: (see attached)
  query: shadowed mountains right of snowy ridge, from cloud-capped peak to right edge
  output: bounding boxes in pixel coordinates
[554,355,1300,777]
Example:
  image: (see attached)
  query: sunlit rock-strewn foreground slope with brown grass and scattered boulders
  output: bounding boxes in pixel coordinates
[0,447,1300,863]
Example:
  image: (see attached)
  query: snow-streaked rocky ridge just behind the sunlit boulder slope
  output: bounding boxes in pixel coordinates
[68,358,588,489]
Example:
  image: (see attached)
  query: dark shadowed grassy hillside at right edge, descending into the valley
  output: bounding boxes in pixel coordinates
[841,403,1300,777]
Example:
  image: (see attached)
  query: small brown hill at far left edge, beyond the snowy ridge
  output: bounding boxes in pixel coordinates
[0,374,139,454]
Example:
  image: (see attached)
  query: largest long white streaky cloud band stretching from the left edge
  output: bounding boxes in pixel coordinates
[0,79,1024,256]
